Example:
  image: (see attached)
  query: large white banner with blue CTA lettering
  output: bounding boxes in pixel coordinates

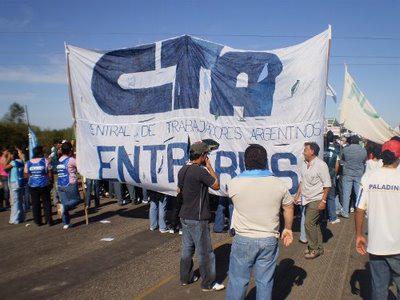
[66,29,331,195]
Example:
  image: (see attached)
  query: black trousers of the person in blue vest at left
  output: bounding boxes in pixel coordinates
[29,186,53,225]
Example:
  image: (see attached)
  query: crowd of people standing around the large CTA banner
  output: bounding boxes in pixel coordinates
[0,131,400,299]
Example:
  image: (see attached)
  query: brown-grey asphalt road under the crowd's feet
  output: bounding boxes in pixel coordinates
[0,199,394,299]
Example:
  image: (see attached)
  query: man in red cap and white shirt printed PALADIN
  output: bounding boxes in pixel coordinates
[356,140,400,300]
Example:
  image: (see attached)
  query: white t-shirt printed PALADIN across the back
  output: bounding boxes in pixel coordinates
[357,167,400,255]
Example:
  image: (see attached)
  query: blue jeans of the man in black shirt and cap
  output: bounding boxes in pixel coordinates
[180,219,216,289]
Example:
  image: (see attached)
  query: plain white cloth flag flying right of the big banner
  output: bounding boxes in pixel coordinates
[340,67,399,144]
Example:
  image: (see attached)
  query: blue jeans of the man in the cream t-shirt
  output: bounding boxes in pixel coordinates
[226,235,279,300]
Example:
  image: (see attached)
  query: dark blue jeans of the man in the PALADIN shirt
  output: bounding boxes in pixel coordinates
[369,254,400,300]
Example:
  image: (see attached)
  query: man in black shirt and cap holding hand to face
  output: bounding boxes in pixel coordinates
[178,142,224,291]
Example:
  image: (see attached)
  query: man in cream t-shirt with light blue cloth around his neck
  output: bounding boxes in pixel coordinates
[226,144,293,300]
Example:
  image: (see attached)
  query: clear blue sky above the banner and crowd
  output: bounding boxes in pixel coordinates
[0,0,400,128]
